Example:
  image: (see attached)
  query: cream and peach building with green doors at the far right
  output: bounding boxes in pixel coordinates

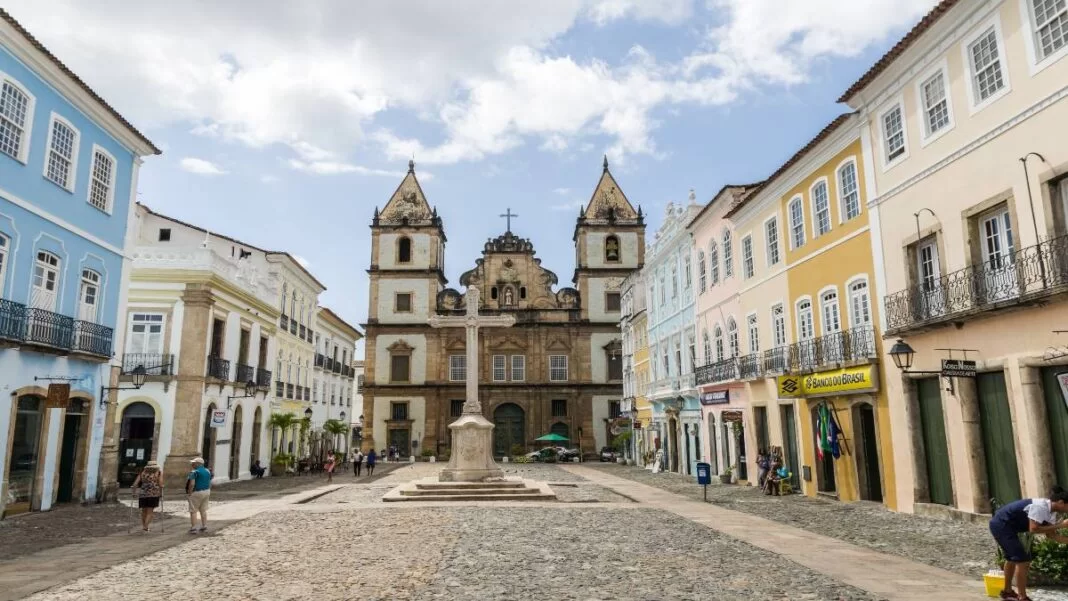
[841,0,1068,513]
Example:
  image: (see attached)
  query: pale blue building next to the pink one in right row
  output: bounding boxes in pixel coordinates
[642,191,702,474]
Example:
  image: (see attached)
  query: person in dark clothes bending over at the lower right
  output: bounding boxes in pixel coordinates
[990,487,1068,601]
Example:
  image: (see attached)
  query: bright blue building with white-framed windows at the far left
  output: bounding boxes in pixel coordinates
[0,9,159,516]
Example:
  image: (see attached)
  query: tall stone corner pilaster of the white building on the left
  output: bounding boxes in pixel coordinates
[163,284,215,491]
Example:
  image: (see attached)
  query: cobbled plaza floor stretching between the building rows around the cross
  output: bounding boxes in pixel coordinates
[0,463,1068,601]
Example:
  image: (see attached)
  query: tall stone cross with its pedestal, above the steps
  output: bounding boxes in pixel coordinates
[427,288,516,483]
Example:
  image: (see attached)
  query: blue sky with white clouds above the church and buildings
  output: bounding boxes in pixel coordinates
[5,0,933,352]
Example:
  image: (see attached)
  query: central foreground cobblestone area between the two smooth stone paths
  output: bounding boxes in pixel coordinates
[29,506,875,601]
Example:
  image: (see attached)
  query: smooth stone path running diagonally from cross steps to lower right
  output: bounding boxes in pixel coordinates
[563,465,983,601]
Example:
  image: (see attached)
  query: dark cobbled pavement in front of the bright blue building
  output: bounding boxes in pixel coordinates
[0,503,180,562]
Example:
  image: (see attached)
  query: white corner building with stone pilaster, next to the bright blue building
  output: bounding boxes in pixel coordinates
[111,205,281,490]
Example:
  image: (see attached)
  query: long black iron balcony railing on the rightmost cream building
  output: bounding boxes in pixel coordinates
[884,236,1068,334]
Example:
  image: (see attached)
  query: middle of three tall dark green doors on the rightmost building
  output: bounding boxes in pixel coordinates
[975,371,1020,505]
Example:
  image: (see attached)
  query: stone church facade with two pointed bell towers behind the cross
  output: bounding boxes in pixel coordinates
[362,160,645,457]
